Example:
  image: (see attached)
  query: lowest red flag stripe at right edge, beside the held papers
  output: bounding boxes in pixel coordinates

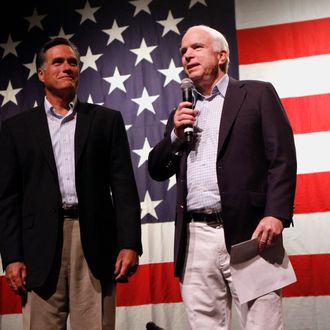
[283,254,330,297]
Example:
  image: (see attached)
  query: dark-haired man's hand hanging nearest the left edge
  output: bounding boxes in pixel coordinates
[5,261,27,295]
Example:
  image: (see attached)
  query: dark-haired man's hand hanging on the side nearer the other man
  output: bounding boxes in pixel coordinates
[115,249,139,282]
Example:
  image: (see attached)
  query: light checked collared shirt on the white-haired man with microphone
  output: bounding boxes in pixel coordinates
[187,74,229,211]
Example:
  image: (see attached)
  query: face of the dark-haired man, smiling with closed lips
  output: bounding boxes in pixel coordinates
[38,45,79,94]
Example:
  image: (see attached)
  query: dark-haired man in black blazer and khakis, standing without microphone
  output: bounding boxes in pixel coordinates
[0,38,142,329]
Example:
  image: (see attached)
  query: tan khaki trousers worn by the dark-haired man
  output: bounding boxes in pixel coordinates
[23,219,115,330]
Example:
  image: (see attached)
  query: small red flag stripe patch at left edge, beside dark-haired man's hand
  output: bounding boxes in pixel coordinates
[0,276,22,315]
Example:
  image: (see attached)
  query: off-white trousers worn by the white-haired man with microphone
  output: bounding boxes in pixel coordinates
[181,222,283,330]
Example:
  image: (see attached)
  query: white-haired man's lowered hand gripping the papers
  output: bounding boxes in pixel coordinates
[252,216,283,251]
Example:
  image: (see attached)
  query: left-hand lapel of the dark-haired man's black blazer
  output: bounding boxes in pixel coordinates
[31,106,57,177]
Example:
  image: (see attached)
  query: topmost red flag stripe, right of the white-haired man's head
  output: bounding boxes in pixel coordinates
[237,18,330,64]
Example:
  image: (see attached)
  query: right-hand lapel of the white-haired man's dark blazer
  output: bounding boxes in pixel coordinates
[218,78,246,155]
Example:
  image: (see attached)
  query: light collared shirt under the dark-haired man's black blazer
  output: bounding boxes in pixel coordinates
[44,97,78,205]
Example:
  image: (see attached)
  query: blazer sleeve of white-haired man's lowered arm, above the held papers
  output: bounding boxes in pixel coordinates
[260,83,297,225]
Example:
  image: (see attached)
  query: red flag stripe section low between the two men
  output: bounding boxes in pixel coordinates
[117,262,182,306]
